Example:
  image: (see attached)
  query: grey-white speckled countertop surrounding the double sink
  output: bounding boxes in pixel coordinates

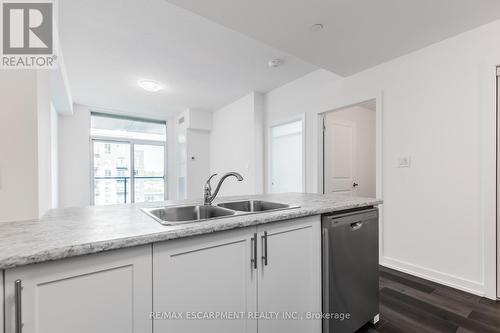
[0,193,382,269]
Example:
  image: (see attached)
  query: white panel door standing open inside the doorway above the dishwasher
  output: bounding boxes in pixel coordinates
[324,116,358,195]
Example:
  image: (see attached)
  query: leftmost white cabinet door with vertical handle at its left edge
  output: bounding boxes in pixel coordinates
[5,246,152,333]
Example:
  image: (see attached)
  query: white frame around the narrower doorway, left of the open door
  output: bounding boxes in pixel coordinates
[266,113,306,193]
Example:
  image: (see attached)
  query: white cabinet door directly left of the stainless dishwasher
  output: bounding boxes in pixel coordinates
[258,216,321,333]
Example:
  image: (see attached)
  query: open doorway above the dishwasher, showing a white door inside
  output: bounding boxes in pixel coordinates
[323,99,377,198]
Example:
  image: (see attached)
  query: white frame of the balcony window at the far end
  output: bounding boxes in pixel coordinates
[89,112,169,206]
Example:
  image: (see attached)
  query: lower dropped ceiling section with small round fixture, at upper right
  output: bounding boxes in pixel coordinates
[168,0,500,76]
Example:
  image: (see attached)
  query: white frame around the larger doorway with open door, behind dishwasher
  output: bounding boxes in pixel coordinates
[317,91,384,256]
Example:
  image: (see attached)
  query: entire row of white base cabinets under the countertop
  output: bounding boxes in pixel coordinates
[0,216,321,333]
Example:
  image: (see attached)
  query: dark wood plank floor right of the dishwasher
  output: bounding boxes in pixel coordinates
[357,267,500,333]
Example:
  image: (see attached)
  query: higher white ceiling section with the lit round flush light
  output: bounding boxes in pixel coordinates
[59,0,316,118]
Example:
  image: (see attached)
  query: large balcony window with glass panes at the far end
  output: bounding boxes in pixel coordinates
[91,113,167,205]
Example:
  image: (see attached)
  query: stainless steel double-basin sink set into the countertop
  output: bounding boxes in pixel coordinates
[142,200,299,225]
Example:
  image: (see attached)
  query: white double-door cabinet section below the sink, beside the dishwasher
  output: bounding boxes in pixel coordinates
[153,216,321,333]
